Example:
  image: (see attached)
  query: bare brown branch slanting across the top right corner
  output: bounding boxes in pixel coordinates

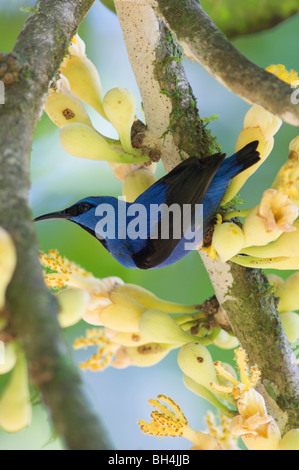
[147,0,299,126]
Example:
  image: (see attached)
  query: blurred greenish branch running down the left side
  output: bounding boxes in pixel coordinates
[0,0,112,450]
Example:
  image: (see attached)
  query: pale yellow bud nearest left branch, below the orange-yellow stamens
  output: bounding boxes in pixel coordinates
[56,287,90,328]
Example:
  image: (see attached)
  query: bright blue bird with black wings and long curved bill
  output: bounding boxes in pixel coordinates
[35,141,260,269]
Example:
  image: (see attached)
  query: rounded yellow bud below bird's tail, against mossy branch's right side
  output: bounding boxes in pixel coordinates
[212,222,244,262]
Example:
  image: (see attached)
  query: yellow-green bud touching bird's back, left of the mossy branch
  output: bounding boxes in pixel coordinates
[122,168,157,202]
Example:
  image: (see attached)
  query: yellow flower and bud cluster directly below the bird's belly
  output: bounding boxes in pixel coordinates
[40,250,230,370]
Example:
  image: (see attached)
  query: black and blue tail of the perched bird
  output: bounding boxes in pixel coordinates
[217,140,260,179]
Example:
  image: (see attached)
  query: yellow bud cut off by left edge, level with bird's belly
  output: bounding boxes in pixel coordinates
[0,227,17,310]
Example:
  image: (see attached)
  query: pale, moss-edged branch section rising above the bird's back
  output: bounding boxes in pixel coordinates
[114,0,217,171]
